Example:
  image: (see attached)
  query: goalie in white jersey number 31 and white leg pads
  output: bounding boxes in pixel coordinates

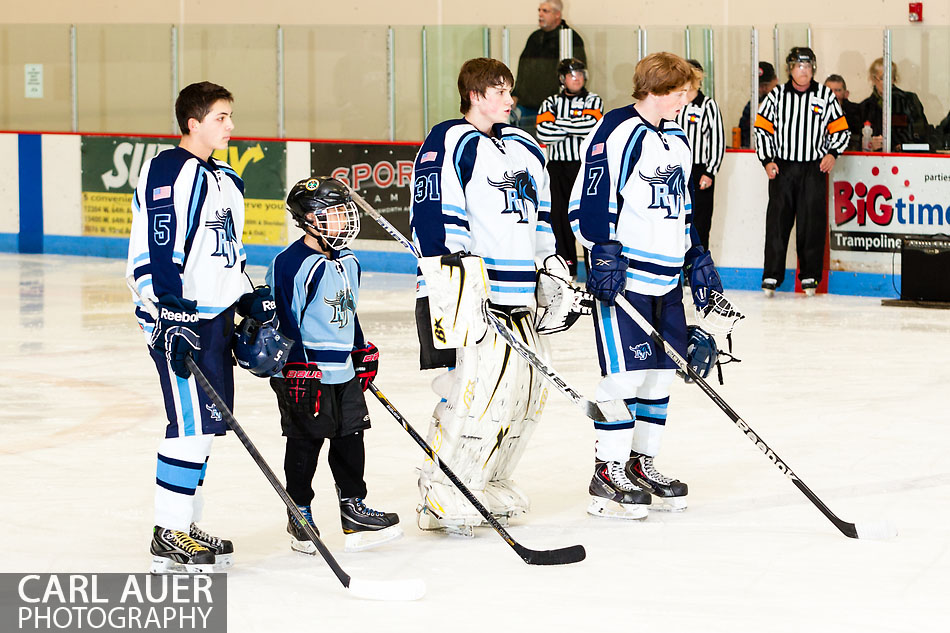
[410,58,566,535]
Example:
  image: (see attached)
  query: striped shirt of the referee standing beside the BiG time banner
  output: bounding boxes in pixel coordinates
[755,80,851,164]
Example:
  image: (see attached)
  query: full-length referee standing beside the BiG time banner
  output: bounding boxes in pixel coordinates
[755,46,851,297]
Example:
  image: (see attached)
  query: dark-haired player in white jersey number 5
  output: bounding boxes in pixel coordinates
[126,82,274,573]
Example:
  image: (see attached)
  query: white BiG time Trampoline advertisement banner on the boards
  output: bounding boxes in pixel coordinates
[828,155,950,273]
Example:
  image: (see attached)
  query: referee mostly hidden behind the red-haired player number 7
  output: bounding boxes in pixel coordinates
[676,59,726,251]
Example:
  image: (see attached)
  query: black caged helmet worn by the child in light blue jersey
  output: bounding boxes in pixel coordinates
[287,176,360,250]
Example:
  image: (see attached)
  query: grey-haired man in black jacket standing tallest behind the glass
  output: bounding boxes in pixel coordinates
[511,0,587,141]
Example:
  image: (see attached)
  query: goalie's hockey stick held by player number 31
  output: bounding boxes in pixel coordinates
[348,187,630,422]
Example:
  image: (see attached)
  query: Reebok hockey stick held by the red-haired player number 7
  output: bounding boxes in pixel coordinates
[616,294,897,539]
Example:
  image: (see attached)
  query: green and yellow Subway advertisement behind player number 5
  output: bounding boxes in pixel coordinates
[81,136,287,246]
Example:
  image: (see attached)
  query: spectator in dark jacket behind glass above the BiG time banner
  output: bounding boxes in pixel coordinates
[861,57,931,152]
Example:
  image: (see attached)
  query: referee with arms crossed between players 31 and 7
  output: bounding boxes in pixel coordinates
[537,59,604,276]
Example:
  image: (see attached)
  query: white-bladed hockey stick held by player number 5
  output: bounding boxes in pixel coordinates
[126,276,426,600]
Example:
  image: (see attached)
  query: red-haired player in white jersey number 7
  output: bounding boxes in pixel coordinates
[569,53,722,519]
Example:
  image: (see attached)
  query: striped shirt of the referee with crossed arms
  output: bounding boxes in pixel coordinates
[537,88,604,161]
